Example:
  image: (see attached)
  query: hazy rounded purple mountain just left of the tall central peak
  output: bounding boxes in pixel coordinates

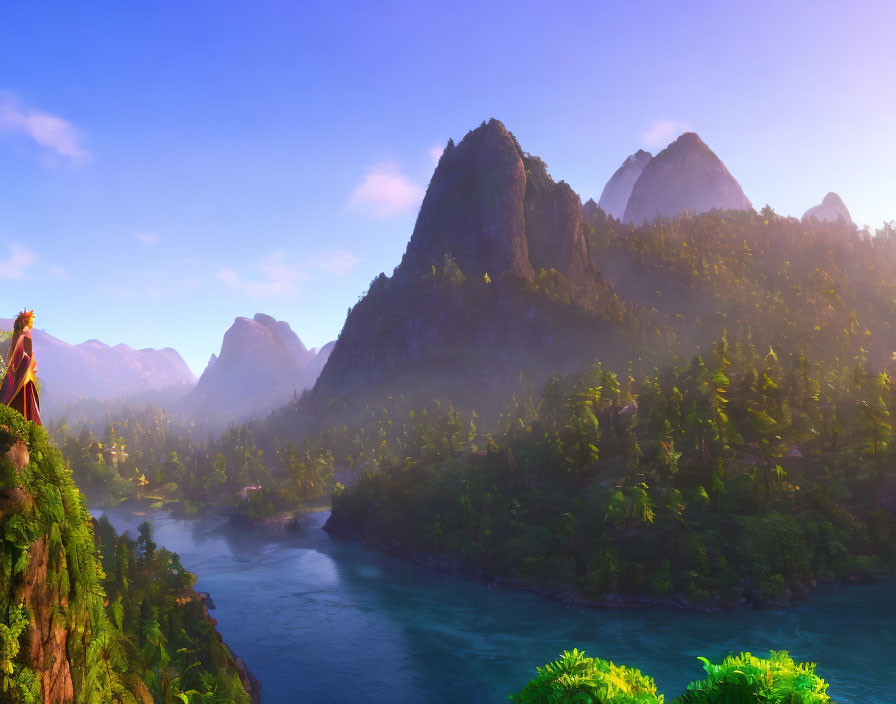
[177,313,333,420]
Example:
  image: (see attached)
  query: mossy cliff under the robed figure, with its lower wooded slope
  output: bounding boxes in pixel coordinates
[0,407,250,704]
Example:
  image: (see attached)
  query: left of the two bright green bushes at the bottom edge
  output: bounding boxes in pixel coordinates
[511,649,663,704]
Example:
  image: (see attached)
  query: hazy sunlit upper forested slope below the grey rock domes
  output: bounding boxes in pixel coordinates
[585,206,896,369]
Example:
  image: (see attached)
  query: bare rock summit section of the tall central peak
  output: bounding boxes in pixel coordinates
[398,119,601,292]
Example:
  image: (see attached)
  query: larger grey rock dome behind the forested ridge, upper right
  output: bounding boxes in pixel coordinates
[622,132,753,225]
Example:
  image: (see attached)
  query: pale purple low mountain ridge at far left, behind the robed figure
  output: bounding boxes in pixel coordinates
[0,319,196,409]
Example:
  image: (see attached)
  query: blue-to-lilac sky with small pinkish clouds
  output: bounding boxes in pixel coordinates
[0,0,896,375]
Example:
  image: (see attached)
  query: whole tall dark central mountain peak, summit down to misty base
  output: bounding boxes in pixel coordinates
[313,120,623,407]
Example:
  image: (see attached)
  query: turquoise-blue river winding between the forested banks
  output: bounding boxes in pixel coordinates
[98,511,896,704]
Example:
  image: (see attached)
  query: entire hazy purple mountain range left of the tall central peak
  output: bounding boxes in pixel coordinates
[0,313,335,421]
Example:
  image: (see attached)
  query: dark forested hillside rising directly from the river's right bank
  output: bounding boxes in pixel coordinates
[328,340,896,607]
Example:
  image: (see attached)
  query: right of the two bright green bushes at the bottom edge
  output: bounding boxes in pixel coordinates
[674,651,831,704]
